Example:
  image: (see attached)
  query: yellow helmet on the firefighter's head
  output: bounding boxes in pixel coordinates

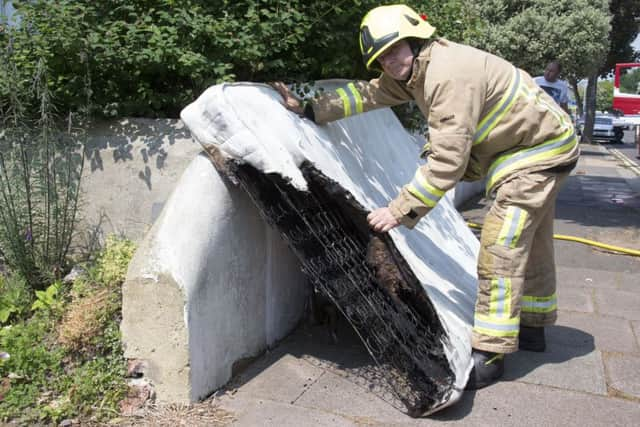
[360,4,436,70]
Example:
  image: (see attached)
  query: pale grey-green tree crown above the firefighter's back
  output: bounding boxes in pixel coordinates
[471,0,611,80]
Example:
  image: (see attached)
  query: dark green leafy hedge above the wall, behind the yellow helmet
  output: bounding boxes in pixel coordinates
[0,0,476,117]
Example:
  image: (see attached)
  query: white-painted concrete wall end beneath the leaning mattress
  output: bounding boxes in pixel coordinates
[121,156,308,402]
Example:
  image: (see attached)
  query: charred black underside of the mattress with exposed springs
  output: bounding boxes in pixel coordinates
[226,163,455,416]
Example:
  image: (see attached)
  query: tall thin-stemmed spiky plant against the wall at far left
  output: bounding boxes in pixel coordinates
[0,50,85,289]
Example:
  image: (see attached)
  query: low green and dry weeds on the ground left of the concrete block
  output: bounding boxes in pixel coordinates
[0,237,133,425]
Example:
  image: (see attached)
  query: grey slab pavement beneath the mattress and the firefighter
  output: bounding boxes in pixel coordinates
[211,140,640,427]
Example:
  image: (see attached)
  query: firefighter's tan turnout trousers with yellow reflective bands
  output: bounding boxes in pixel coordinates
[472,171,568,353]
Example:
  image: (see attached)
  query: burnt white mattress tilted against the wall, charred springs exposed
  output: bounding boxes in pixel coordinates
[181,81,478,416]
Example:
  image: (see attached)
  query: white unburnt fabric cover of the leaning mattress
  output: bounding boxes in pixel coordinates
[181,81,479,412]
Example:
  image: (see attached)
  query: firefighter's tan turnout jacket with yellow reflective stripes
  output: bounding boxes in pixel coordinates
[311,39,579,228]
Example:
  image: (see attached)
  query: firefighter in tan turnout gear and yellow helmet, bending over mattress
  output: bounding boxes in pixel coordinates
[274,5,579,389]
